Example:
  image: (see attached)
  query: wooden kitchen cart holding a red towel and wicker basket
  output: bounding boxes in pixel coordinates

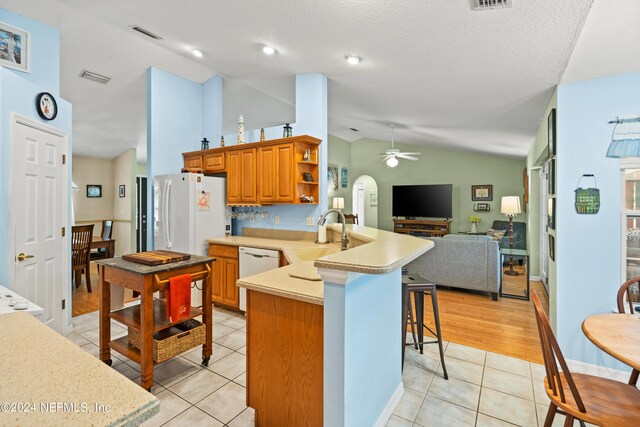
[97,255,215,390]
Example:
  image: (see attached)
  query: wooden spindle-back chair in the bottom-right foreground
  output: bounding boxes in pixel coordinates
[532,291,640,427]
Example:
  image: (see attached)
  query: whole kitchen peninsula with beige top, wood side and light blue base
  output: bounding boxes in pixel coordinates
[209,225,433,426]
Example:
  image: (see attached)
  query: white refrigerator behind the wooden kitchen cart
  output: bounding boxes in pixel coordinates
[153,173,227,307]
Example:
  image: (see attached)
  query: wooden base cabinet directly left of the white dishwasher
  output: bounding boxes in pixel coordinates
[209,243,240,309]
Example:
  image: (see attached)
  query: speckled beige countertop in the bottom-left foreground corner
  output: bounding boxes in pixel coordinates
[0,312,160,426]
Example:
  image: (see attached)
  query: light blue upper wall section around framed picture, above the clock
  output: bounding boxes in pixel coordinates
[0,9,60,93]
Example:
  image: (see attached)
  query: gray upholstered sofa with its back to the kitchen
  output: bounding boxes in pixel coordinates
[406,234,501,301]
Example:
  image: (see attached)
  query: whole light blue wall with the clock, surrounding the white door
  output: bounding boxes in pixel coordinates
[0,9,72,290]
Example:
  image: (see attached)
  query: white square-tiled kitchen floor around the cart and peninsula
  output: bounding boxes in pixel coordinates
[68,308,596,427]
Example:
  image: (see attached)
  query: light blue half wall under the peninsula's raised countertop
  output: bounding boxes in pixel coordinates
[324,269,402,427]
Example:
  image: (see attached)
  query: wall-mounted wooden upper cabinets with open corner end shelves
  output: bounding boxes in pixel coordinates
[182,135,321,205]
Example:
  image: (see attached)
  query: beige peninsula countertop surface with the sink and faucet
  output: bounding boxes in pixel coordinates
[208,224,433,305]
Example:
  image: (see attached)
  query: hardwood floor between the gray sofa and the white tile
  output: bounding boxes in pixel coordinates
[424,267,549,363]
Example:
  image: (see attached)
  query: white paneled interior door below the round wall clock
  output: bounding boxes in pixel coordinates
[10,115,71,332]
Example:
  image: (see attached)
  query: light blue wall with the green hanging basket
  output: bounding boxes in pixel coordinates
[556,73,640,367]
